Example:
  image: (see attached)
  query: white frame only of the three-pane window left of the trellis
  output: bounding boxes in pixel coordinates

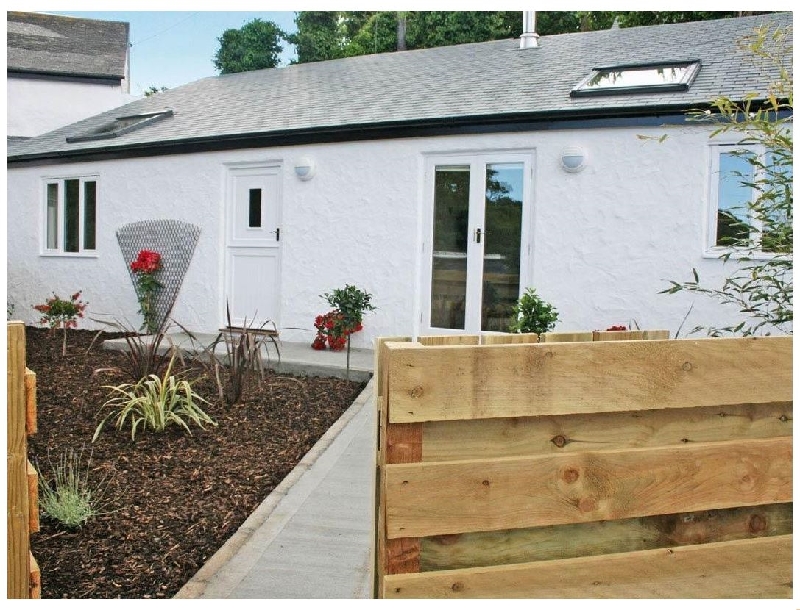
[39,174,100,258]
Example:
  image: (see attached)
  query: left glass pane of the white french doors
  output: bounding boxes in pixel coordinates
[430,165,470,330]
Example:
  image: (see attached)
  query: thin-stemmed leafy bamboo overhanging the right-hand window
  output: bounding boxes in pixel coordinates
[662,28,794,336]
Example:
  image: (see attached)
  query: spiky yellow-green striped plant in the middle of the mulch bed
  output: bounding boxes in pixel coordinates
[92,356,217,442]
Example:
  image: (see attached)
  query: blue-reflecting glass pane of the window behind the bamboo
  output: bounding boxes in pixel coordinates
[716,153,753,246]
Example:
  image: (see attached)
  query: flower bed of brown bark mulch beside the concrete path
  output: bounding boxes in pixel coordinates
[21,327,364,598]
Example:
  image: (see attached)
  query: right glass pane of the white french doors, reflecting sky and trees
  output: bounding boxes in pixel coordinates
[481,163,524,332]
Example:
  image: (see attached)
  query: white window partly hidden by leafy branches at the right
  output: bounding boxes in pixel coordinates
[707,144,792,257]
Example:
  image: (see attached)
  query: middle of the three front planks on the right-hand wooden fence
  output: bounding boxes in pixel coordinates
[385,437,792,538]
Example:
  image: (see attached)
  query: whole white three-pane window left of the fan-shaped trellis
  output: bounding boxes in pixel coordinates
[42,176,97,255]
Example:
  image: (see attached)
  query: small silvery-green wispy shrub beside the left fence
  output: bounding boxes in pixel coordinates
[36,449,101,529]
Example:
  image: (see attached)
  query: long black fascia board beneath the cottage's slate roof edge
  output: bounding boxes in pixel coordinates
[7,103,792,167]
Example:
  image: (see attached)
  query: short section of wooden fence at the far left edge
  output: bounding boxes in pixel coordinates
[6,322,41,599]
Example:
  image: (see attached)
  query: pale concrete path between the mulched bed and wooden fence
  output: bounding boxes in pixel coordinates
[176,381,377,599]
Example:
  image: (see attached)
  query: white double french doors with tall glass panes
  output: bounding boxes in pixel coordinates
[421,154,532,333]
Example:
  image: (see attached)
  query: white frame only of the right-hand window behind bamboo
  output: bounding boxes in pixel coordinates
[703,139,779,260]
